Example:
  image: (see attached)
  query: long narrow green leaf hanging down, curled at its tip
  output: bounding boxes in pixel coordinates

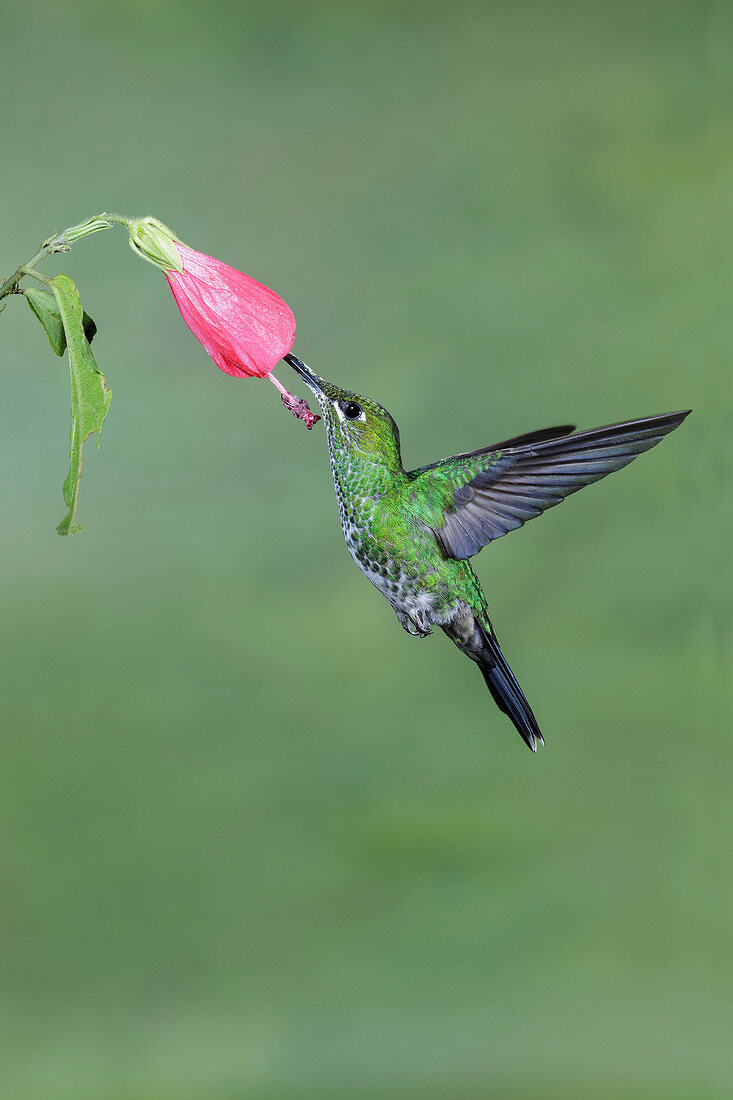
[51,275,112,535]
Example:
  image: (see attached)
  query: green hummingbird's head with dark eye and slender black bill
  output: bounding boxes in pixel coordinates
[285,354,402,470]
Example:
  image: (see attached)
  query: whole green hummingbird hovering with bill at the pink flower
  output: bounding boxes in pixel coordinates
[285,354,690,752]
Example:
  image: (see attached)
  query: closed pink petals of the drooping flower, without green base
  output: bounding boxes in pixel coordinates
[165,242,295,378]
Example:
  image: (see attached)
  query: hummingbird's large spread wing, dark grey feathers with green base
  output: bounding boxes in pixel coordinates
[409,409,690,561]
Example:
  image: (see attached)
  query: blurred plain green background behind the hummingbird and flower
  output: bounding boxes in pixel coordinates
[0,0,733,1100]
